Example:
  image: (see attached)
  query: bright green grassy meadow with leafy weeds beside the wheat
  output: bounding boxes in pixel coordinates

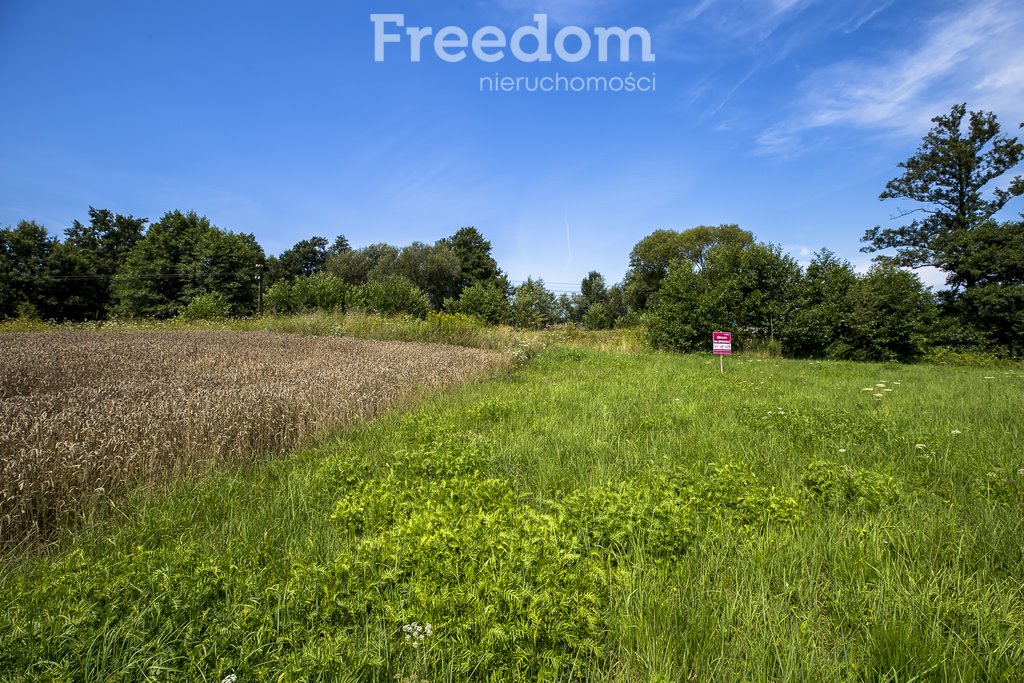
[0,347,1024,683]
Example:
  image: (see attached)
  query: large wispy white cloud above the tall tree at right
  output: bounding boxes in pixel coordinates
[758,0,1024,152]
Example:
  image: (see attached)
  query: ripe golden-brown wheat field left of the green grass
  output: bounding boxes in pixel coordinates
[0,332,508,545]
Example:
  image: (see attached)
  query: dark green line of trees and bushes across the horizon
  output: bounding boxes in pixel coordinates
[0,104,1024,360]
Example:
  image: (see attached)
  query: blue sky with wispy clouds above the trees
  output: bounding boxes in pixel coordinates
[0,0,1024,289]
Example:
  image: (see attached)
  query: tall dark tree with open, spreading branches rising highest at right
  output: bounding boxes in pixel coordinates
[861,104,1024,288]
